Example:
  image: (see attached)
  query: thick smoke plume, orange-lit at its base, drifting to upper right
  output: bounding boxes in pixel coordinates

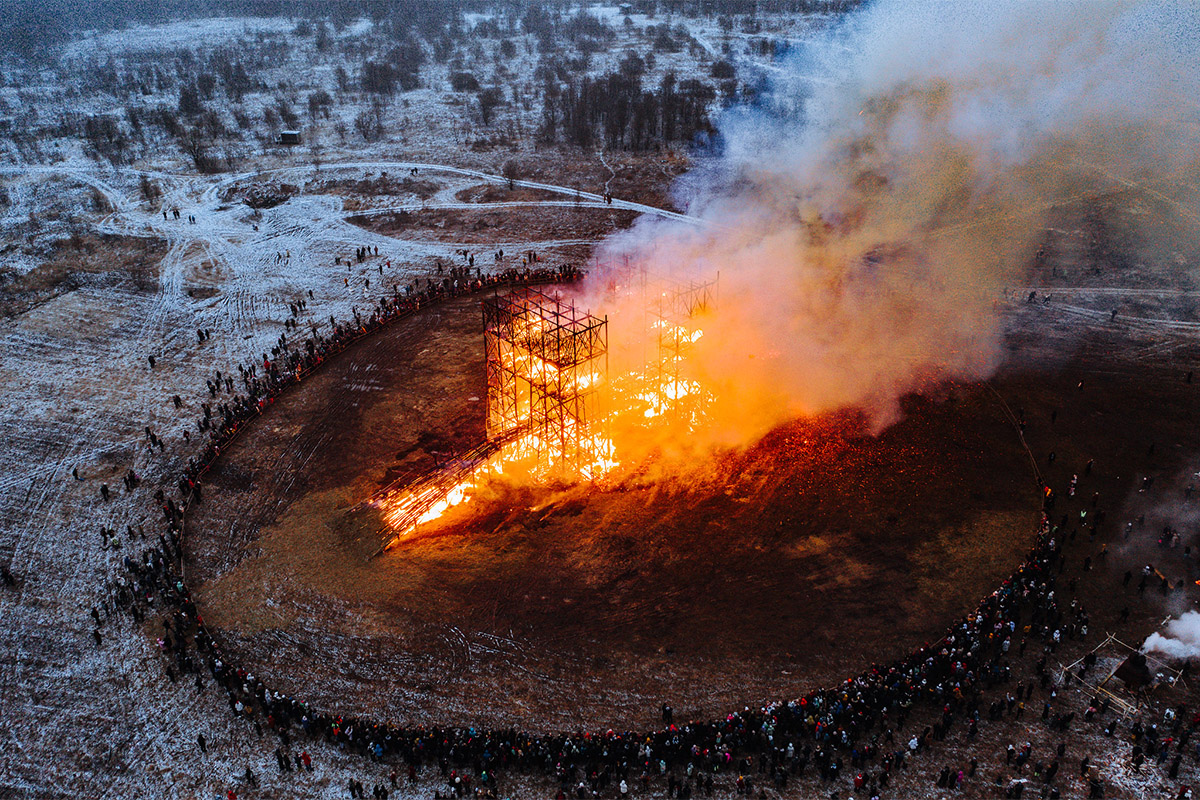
[601,0,1200,455]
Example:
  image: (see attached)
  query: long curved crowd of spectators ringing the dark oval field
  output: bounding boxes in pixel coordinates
[75,267,1200,800]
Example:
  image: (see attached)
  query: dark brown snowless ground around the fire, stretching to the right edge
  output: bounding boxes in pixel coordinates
[180,280,1200,730]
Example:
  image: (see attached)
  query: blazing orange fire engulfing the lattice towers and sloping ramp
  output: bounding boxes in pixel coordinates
[371,278,709,541]
